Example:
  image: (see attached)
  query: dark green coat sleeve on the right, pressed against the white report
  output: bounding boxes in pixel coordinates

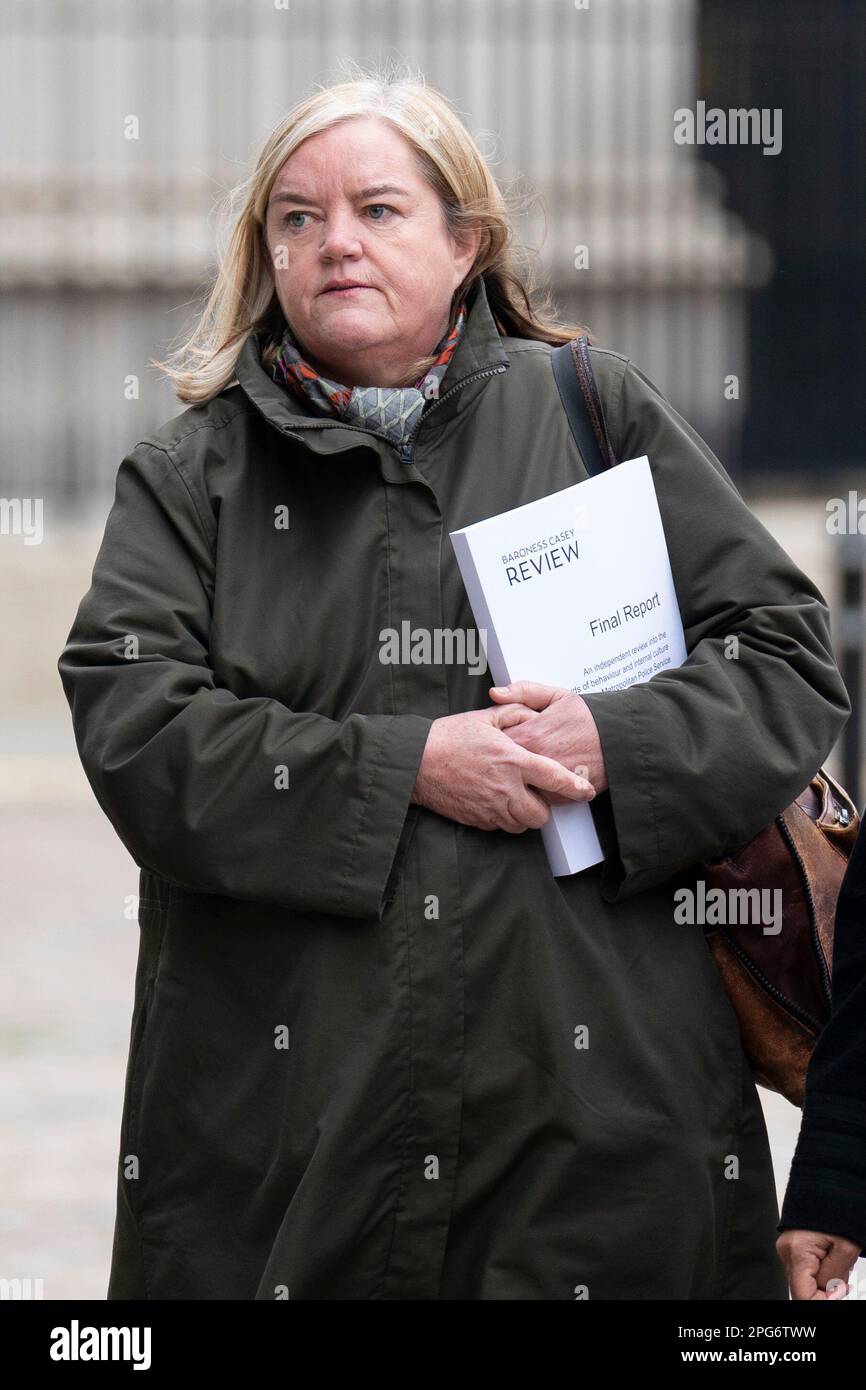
[584,353,851,902]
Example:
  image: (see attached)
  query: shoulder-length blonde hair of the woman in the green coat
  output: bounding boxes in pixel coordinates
[150,60,587,404]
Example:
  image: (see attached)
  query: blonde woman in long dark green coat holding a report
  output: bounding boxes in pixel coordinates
[60,62,849,1300]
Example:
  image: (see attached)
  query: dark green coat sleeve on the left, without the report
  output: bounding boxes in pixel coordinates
[58,443,432,917]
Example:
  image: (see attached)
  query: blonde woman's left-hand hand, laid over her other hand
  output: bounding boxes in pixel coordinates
[411,705,595,834]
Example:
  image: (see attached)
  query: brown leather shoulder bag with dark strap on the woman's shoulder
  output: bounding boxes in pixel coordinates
[552,336,860,1106]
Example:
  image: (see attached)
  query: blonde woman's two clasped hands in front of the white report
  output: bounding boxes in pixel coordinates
[411,681,607,834]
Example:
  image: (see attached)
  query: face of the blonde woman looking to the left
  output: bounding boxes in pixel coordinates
[265,117,478,385]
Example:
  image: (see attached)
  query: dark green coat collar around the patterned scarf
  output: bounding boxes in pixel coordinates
[235,279,509,453]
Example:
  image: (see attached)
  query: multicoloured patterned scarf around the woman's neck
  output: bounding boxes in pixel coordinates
[271,300,467,445]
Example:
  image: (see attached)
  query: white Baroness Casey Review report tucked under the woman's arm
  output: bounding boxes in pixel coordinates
[450,455,687,877]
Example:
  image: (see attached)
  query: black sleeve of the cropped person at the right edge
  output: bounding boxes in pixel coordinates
[778,828,866,1250]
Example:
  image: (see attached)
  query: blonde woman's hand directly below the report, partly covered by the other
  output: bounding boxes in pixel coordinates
[491,681,607,806]
